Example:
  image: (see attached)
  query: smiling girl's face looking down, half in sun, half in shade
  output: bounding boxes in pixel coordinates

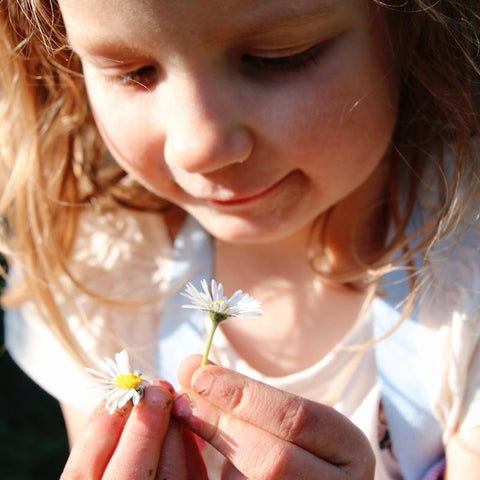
[60,0,397,242]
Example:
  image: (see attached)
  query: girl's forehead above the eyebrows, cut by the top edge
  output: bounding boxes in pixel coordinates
[59,0,364,49]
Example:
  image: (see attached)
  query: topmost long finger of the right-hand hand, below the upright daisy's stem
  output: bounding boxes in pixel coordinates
[186,366,370,465]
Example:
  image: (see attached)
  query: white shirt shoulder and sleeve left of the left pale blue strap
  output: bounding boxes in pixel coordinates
[5,205,176,410]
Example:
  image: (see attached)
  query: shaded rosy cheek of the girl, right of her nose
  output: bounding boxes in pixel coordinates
[270,52,397,180]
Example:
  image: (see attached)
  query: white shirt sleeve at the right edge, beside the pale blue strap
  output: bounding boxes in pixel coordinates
[421,218,480,443]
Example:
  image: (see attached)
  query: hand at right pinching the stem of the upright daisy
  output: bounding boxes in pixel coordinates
[172,357,375,480]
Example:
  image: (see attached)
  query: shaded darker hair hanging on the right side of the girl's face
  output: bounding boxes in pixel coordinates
[310,0,480,280]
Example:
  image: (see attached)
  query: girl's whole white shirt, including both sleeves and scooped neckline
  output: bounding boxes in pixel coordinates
[6,210,480,480]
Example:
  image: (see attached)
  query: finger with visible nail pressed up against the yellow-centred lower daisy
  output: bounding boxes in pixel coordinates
[103,384,173,480]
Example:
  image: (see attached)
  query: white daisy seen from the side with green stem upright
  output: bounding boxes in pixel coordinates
[181,279,262,365]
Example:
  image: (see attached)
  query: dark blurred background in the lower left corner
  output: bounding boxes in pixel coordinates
[0,259,68,480]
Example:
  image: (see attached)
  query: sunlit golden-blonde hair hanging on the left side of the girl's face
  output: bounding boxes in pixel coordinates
[0,0,166,360]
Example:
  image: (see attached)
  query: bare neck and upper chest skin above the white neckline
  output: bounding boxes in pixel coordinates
[215,223,370,376]
